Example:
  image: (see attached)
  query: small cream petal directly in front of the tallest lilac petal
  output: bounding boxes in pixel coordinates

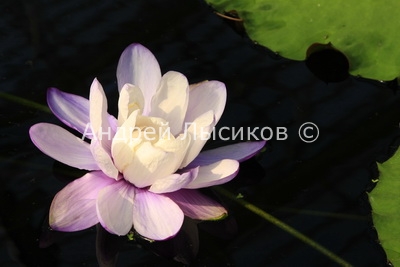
[118,83,144,125]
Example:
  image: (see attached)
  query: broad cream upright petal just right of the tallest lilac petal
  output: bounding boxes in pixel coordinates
[150,71,189,135]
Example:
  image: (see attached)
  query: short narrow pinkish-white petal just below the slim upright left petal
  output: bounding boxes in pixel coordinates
[90,139,120,180]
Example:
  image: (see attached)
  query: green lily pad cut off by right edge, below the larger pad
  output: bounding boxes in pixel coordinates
[369,149,400,266]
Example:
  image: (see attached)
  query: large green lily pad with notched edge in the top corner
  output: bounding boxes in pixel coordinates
[206,0,400,80]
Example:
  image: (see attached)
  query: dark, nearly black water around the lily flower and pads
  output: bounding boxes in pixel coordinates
[0,0,400,266]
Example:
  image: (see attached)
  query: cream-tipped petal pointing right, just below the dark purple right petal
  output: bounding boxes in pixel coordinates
[184,159,239,189]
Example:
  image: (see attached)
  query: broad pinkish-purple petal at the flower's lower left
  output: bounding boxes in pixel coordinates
[49,171,115,232]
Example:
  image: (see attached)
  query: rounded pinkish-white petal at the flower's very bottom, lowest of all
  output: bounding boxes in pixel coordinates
[133,189,184,240]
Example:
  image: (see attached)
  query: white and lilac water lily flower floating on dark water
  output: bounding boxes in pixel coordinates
[30,44,264,240]
